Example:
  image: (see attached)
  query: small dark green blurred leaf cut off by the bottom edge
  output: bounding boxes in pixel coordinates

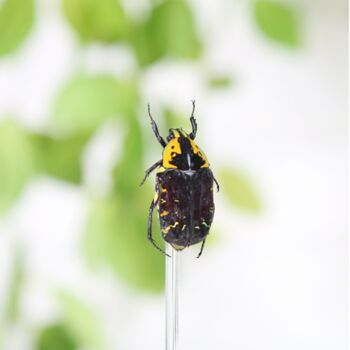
[35,323,78,350]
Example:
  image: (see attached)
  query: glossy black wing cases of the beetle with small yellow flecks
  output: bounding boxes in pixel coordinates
[156,168,214,249]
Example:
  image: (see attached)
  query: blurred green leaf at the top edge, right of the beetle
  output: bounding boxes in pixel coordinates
[254,0,300,46]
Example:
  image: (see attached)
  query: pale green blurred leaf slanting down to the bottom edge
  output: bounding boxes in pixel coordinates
[59,292,106,350]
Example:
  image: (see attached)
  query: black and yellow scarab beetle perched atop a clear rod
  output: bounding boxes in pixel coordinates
[141,101,219,258]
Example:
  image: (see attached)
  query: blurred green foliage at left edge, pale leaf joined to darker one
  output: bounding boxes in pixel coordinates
[0,120,89,214]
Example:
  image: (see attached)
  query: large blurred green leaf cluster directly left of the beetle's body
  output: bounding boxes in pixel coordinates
[85,119,164,292]
